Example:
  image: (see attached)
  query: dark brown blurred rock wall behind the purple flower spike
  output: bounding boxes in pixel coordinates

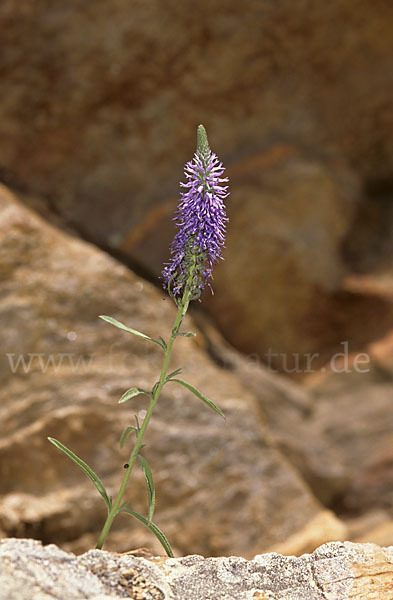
[0,0,393,371]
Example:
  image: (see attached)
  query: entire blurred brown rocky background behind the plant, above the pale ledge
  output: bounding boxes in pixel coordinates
[0,0,393,556]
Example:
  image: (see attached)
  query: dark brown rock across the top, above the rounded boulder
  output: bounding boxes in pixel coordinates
[0,0,393,230]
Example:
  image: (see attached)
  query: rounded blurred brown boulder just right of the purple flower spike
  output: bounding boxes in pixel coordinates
[202,156,355,374]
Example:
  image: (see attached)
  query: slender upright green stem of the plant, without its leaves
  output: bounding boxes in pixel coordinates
[96,282,193,550]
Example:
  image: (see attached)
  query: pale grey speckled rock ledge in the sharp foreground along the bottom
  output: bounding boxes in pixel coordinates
[0,539,393,600]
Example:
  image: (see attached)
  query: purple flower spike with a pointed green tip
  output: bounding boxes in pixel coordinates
[162,125,229,300]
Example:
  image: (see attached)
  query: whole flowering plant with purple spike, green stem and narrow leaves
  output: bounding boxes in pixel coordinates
[48,125,228,556]
